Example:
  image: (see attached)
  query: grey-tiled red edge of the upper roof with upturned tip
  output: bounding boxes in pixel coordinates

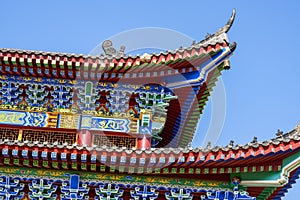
[0,10,236,74]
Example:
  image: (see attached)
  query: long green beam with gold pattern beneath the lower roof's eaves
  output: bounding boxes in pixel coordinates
[0,166,232,188]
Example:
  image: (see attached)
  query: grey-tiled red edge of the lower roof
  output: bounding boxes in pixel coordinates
[0,125,300,167]
